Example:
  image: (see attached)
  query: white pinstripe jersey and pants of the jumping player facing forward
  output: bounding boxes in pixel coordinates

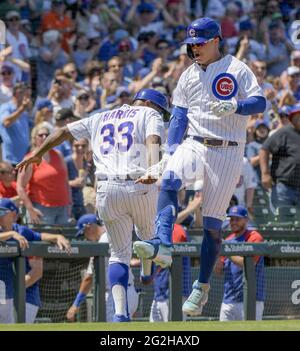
[170,55,263,220]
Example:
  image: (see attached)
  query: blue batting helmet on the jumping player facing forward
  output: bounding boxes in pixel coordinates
[184,17,222,59]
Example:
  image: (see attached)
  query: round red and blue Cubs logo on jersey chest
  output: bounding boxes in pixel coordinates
[212,73,238,100]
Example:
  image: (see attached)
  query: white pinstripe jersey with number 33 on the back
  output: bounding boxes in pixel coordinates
[67,105,165,176]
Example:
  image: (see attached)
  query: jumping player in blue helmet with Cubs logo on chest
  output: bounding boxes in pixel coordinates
[134,18,266,316]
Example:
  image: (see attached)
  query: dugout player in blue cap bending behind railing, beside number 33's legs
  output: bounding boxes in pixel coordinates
[67,214,139,322]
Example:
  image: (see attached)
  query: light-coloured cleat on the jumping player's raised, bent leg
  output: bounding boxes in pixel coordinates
[133,241,172,268]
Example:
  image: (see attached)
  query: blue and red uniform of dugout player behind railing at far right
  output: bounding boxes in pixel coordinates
[220,230,265,321]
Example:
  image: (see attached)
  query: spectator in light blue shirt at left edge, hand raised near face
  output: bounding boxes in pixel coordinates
[0,83,32,165]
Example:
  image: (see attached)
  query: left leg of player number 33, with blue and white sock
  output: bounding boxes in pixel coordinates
[97,184,133,322]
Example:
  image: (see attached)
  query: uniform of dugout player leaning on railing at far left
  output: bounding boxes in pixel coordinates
[0,224,41,323]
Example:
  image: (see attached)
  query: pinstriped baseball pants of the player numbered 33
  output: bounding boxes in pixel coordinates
[97,180,158,265]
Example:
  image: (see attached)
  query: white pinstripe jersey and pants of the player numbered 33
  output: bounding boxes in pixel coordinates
[68,105,165,265]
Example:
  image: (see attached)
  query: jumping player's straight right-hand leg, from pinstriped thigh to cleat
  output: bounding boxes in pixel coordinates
[183,147,243,316]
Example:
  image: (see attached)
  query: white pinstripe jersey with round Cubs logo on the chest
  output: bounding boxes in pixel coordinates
[172,55,263,142]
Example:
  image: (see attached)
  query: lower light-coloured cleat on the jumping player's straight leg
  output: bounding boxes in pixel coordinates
[182,280,209,316]
